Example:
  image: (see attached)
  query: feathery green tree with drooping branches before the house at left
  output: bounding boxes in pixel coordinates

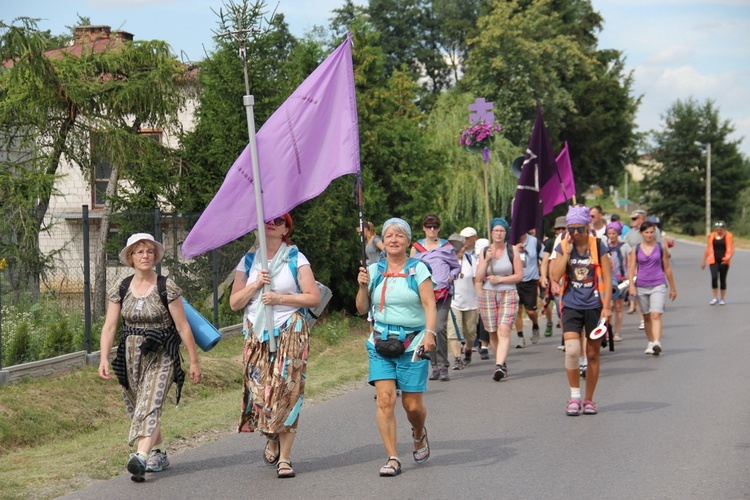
[0,20,187,311]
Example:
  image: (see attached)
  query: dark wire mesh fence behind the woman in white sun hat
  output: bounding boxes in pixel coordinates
[0,205,254,368]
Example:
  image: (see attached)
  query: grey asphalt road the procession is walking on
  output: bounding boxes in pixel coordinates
[65,242,750,499]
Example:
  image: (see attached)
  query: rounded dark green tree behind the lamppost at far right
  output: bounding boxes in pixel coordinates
[643,97,750,234]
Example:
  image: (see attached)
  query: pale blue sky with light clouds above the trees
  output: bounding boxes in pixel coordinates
[0,0,750,158]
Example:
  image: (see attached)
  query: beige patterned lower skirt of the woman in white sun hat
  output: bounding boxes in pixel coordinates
[122,335,174,446]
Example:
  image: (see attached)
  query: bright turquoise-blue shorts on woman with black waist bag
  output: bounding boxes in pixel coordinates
[365,342,430,392]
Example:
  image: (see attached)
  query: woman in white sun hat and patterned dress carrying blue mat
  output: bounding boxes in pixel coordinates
[99,233,202,482]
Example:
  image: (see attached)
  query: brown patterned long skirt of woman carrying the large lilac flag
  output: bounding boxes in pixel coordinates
[239,313,309,436]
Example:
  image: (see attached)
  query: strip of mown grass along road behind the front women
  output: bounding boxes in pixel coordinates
[0,316,367,499]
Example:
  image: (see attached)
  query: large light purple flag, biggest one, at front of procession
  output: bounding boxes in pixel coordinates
[182,38,359,259]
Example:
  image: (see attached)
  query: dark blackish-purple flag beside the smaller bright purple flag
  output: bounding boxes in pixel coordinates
[510,104,555,245]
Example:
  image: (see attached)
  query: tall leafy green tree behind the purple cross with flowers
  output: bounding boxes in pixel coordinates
[461,0,638,190]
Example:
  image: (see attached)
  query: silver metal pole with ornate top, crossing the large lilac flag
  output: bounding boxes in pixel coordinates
[224,25,276,355]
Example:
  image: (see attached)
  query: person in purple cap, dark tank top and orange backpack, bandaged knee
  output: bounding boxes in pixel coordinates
[550,206,612,417]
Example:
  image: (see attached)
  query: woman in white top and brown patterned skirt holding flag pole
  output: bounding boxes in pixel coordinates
[229,214,320,478]
